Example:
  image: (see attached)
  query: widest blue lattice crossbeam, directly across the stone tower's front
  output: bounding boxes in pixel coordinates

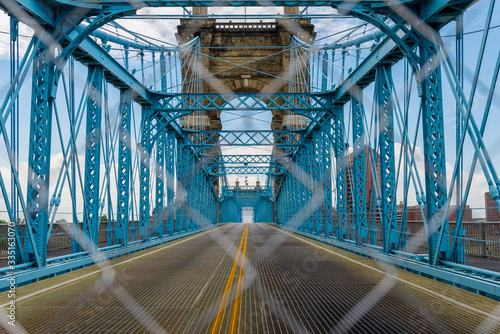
[154,93,331,112]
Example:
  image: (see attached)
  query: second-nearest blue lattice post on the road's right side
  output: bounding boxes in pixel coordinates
[374,64,398,253]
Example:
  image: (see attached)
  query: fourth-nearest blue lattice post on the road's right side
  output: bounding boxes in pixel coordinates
[334,106,348,240]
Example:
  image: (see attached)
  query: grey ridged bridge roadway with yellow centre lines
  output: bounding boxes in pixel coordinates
[0,224,500,334]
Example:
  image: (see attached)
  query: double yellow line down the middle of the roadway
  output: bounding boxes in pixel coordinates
[210,224,248,334]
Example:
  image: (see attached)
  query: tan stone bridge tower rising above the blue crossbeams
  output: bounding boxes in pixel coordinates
[176,7,316,130]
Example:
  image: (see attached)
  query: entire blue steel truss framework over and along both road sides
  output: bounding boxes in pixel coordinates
[0,0,500,296]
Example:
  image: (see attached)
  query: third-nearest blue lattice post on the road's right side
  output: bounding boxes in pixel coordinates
[351,90,368,245]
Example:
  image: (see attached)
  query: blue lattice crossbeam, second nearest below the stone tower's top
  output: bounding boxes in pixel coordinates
[185,130,304,148]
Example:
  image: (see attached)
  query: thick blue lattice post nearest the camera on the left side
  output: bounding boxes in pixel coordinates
[24,39,56,267]
